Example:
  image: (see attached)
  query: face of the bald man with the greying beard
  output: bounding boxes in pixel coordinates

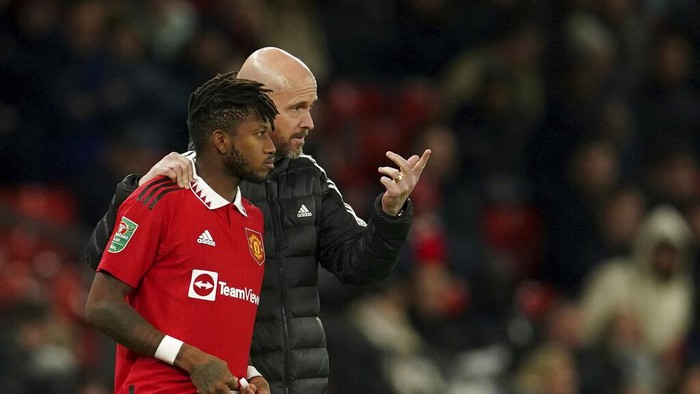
[270,74,318,159]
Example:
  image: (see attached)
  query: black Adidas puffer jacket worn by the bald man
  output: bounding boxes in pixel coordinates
[86,156,412,394]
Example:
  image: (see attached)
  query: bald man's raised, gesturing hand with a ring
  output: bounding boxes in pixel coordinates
[378,149,431,216]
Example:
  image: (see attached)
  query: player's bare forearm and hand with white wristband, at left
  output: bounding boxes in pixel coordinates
[85,271,238,394]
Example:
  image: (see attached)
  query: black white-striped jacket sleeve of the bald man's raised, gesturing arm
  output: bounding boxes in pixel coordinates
[319,169,413,286]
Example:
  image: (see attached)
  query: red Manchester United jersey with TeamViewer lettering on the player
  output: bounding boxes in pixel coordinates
[98,177,265,394]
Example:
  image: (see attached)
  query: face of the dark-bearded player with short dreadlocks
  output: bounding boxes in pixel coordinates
[224,113,275,183]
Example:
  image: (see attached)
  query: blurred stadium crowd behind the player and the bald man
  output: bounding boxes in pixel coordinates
[0,0,700,394]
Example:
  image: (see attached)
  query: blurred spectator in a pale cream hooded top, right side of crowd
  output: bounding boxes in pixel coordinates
[581,206,694,390]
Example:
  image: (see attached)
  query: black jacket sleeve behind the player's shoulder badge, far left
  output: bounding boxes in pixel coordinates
[85,174,141,269]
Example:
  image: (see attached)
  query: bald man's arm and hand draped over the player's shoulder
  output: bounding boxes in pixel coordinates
[85,152,194,269]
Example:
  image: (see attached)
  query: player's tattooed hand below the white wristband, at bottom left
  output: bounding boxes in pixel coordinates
[175,344,238,394]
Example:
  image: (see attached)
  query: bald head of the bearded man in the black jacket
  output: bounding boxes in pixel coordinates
[238,48,318,158]
